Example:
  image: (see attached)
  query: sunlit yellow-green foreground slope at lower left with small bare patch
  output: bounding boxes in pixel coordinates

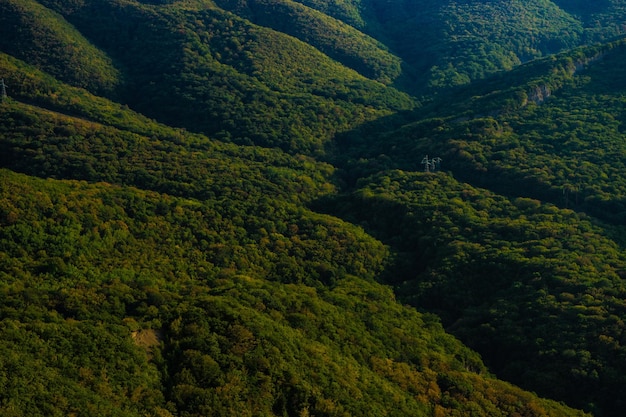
[0,170,582,416]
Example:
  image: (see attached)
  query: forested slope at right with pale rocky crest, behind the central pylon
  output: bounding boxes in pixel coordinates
[336,39,626,224]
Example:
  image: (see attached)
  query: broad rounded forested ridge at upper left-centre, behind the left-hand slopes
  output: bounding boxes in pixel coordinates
[33,0,413,154]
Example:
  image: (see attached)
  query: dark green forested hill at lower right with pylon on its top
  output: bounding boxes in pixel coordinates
[326,171,626,415]
